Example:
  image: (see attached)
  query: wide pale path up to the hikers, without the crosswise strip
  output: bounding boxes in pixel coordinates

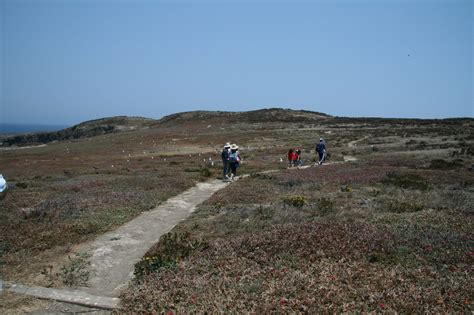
[79,180,228,297]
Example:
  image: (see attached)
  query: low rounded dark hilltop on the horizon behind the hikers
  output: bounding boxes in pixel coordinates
[158,108,332,124]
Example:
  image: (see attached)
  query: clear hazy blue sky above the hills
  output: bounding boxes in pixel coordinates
[0,0,474,124]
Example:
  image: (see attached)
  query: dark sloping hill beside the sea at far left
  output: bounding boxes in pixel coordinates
[0,116,156,146]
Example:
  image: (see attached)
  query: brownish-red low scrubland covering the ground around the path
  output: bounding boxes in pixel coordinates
[0,109,474,312]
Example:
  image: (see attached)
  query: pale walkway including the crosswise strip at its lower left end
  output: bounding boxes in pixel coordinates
[0,180,229,309]
